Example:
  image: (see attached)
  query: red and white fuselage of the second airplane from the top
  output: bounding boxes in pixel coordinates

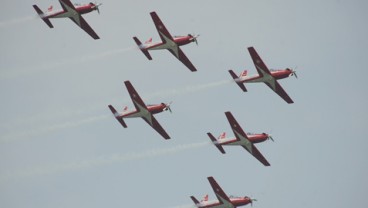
[141,35,195,50]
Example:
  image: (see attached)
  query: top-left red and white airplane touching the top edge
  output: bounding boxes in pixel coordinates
[33,0,102,39]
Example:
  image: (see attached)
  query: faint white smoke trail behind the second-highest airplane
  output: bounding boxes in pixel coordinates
[0,46,137,80]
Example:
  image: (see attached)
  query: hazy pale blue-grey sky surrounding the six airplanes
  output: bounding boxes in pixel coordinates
[0,0,368,208]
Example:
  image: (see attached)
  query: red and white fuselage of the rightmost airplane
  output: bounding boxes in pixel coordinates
[236,68,293,83]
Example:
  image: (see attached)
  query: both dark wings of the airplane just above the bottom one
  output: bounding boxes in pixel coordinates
[225,112,270,166]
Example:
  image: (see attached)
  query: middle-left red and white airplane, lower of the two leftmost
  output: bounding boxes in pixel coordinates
[109,81,171,139]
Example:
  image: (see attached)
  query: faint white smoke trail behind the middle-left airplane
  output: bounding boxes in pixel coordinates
[0,115,109,143]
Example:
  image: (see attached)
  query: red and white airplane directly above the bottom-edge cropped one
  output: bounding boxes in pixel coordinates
[207,111,273,166]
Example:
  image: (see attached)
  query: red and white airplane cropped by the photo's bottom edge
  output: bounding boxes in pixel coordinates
[190,176,257,208]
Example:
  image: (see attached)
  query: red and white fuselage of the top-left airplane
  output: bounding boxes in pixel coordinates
[44,3,97,18]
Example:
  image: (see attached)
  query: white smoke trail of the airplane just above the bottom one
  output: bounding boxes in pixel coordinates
[0,142,211,183]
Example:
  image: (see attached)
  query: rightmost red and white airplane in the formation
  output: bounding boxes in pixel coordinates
[229,47,298,104]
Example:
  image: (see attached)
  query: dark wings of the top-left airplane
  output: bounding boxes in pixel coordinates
[59,0,100,40]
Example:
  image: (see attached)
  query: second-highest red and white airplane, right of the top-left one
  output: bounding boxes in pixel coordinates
[133,12,199,72]
